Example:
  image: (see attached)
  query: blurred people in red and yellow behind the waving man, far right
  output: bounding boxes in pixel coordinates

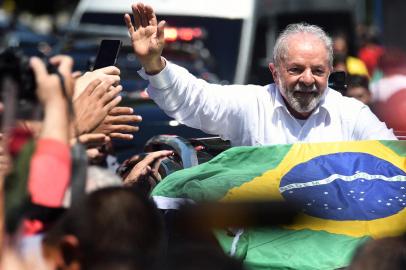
[333,25,406,136]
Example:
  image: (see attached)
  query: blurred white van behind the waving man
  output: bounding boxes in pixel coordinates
[70,0,363,84]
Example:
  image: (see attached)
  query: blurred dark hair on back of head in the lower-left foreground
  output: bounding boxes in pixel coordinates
[44,187,163,269]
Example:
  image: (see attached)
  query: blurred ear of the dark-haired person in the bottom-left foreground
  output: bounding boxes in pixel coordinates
[60,234,80,269]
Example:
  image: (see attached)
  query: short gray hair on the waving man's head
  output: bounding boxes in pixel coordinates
[273,23,333,67]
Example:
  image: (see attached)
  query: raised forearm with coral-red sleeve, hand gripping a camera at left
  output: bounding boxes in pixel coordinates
[28,56,73,207]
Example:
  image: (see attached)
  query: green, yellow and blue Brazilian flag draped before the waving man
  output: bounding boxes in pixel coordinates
[152,141,406,269]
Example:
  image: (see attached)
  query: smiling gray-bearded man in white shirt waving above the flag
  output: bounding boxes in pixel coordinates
[124,3,396,146]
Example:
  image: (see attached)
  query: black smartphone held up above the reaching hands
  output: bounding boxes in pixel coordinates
[93,39,122,70]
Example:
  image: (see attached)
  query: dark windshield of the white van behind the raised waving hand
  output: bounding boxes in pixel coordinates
[81,12,242,84]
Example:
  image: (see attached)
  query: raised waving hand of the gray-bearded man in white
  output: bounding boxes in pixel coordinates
[124,3,165,74]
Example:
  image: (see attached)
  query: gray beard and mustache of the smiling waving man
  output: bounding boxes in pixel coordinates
[279,80,321,113]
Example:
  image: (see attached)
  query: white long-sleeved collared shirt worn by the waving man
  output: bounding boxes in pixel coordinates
[139,61,396,146]
